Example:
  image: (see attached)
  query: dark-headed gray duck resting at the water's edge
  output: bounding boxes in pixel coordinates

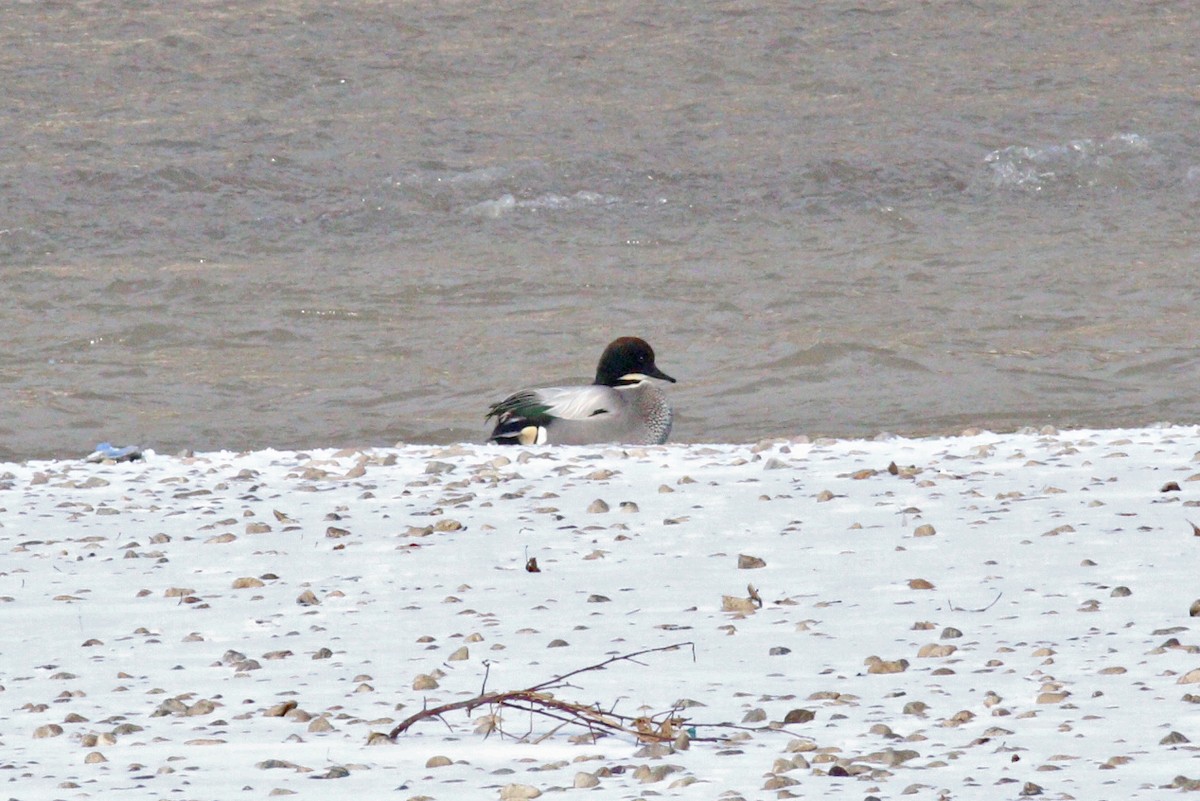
[487,337,674,445]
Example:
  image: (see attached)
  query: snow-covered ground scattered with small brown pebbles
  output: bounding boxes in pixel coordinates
[0,427,1200,801]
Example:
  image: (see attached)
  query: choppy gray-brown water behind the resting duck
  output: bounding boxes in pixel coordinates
[0,0,1200,459]
